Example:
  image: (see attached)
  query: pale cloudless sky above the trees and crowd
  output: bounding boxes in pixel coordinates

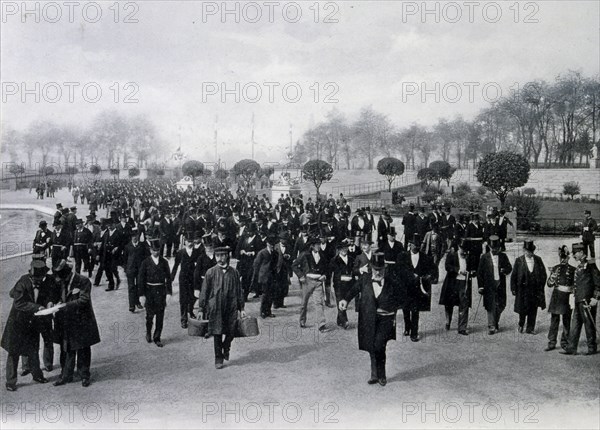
[0,1,600,165]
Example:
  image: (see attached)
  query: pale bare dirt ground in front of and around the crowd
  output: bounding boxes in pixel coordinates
[0,189,600,428]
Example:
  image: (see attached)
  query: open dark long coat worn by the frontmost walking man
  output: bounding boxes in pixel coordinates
[344,274,402,352]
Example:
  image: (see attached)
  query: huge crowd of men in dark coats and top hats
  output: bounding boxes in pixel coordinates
[2,180,600,391]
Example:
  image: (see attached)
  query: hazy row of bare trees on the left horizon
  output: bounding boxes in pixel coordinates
[1,111,165,169]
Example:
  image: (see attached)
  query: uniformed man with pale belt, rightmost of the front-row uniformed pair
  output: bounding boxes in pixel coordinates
[560,243,600,355]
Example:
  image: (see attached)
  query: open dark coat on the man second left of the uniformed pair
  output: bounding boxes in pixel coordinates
[477,252,512,312]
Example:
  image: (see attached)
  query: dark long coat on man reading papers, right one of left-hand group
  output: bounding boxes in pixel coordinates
[54,273,100,351]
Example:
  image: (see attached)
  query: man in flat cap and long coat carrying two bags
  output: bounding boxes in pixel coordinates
[198,247,246,369]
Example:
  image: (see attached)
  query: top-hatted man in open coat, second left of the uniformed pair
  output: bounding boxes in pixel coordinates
[477,236,512,334]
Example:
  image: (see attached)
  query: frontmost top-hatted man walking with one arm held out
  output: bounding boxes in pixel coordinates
[339,253,401,386]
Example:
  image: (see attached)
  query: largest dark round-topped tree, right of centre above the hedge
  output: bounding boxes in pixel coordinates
[477,151,530,206]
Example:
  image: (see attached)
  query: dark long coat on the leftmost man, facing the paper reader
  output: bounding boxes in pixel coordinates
[0,275,58,355]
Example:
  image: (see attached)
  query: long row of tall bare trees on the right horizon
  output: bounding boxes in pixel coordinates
[291,71,600,169]
